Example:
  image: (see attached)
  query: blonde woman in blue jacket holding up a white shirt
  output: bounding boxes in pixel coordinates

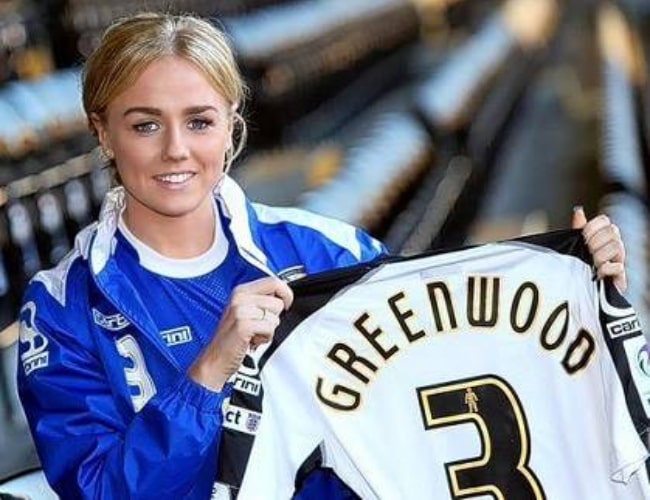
[19,14,625,499]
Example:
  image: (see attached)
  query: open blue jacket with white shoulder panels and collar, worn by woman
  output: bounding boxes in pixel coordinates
[18,177,386,499]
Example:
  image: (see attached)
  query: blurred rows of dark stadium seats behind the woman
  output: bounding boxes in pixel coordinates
[0,0,650,492]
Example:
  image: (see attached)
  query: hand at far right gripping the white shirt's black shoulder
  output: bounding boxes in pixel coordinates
[572,207,627,292]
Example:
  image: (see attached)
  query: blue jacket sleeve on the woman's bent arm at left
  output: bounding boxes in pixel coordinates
[18,283,228,499]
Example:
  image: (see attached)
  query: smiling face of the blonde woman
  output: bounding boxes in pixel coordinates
[94,56,231,222]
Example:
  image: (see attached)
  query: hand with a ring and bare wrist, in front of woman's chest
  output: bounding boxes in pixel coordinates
[189,277,293,391]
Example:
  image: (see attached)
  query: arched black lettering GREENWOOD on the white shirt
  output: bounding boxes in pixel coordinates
[315,276,596,411]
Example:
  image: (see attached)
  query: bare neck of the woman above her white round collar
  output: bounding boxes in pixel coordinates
[123,195,217,259]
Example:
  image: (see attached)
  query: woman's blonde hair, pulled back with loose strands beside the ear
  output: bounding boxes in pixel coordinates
[82,12,247,170]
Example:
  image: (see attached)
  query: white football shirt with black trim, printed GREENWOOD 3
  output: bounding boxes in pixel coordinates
[215,231,650,500]
